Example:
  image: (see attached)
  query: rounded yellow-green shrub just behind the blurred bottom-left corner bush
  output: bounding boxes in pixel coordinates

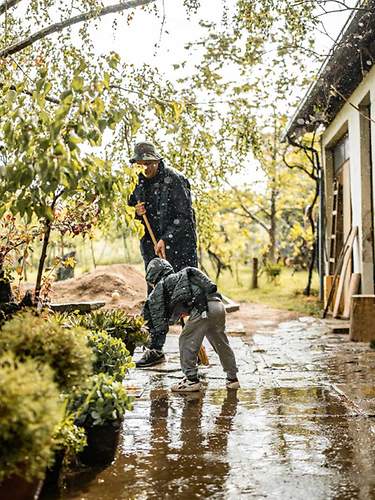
[0,312,93,391]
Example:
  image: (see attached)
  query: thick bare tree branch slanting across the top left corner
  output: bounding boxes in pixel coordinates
[0,0,156,59]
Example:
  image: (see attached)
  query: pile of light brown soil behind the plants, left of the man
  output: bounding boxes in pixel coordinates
[51,264,147,312]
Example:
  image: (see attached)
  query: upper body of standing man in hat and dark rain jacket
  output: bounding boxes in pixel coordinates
[129,142,198,280]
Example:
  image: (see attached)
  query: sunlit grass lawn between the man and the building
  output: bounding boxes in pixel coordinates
[213,266,322,316]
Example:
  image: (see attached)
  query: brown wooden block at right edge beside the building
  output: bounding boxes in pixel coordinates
[349,295,375,342]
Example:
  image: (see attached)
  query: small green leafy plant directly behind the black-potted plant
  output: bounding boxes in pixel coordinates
[88,330,134,381]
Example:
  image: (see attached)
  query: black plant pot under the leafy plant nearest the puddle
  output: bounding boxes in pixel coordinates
[79,421,121,465]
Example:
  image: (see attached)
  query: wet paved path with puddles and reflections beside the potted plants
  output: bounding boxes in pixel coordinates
[62,318,375,500]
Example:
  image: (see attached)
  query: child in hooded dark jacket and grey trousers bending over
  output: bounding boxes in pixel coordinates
[137,258,239,392]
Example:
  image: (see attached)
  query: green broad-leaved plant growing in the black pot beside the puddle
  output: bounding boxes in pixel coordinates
[71,373,132,427]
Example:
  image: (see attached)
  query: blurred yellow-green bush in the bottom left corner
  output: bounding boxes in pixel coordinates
[0,353,63,482]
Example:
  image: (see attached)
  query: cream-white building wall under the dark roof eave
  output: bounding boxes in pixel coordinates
[322,63,375,282]
